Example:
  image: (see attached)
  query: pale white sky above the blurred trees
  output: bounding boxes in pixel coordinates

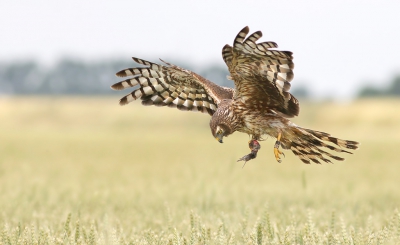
[0,0,400,98]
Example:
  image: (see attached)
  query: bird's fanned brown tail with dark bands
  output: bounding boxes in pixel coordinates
[282,127,359,164]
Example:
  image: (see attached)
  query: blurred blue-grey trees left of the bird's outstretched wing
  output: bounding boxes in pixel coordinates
[0,59,132,94]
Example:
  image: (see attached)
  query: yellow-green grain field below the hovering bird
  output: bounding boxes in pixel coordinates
[0,97,400,244]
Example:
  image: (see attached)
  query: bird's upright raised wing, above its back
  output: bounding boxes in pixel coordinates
[222,26,299,117]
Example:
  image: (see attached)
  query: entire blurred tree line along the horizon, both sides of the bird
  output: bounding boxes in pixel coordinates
[0,59,400,98]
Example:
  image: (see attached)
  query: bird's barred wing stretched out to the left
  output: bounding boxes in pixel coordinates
[111,57,234,115]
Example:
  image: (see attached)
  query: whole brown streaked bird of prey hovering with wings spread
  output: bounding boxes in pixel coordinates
[111,27,359,163]
